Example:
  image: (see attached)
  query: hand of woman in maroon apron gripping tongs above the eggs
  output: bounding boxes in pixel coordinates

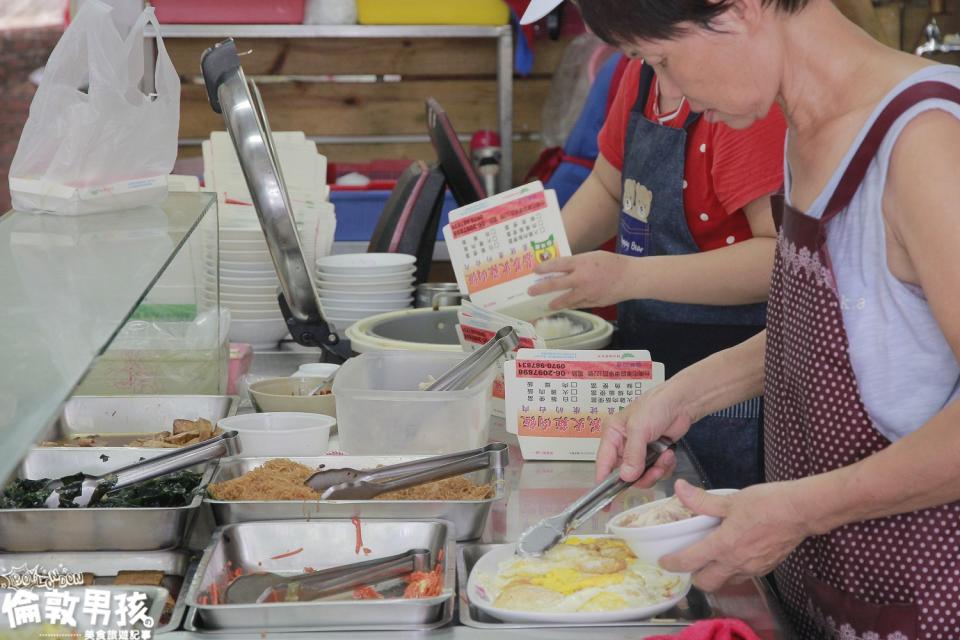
[597,382,693,487]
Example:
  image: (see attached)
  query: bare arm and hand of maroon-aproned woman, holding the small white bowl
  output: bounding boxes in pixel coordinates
[662,112,960,590]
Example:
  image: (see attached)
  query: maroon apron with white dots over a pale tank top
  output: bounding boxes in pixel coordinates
[764,82,960,640]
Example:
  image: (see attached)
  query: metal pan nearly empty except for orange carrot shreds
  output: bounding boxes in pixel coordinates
[187,520,456,632]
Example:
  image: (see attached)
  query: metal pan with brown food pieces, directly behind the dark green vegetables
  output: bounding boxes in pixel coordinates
[41,396,239,453]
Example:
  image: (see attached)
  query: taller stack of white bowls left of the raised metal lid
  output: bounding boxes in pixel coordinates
[202,226,287,350]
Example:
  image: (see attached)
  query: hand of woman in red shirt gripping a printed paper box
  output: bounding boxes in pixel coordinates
[528,251,637,309]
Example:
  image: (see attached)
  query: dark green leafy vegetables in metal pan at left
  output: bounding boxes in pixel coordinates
[0,471,201,509]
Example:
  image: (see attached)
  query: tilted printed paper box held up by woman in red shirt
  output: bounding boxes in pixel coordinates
[443,182,571,320]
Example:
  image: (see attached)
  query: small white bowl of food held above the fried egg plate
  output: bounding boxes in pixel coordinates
[607,489,738,565]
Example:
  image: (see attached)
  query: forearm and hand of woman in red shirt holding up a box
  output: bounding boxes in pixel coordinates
[530,191,776,309]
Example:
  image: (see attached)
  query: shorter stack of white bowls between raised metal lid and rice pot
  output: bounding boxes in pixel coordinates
[317,253,416,333]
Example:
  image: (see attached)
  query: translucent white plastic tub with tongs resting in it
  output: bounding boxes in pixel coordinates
[333,351,494,455]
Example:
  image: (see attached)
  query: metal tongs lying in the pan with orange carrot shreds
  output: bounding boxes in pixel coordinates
[257,549,430,602]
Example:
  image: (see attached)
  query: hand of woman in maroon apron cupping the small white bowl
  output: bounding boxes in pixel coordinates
[660,480,813,591]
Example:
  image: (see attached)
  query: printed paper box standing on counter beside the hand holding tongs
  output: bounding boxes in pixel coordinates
[503,349,664,460]
